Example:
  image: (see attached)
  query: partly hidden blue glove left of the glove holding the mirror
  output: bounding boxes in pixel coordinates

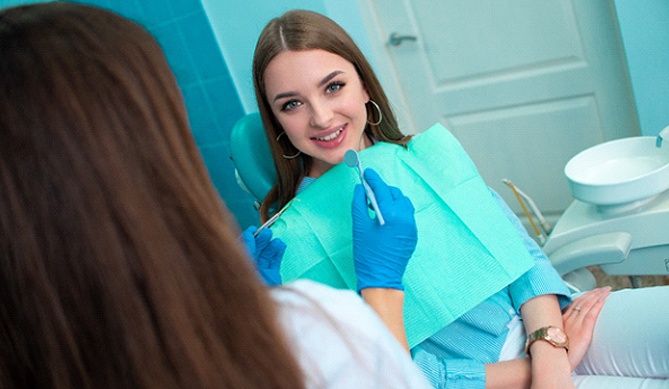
[242,226,286,286]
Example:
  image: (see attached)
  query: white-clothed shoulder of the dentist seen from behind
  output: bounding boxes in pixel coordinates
[272,280,426,388]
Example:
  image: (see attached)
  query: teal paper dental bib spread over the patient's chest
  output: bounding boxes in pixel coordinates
[272,124,534,347]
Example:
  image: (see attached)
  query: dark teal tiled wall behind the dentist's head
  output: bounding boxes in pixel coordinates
[0,0,258,228]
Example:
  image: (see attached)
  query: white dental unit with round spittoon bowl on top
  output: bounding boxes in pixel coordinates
[543,126,669,290]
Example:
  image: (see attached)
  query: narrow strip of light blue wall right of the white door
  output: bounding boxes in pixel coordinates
[615,0,669,136]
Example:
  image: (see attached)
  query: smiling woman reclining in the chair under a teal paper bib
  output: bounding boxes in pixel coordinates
[254,11,669,388]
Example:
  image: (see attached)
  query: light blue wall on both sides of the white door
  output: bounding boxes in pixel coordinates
[202,0,669,135]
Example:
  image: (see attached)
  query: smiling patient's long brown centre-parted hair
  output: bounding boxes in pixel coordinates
[253,10,411,221]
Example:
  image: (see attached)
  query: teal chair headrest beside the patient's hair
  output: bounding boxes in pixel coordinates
[230,112,276,203]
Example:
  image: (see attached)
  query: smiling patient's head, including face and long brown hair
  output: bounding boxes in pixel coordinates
[253,11,411,220]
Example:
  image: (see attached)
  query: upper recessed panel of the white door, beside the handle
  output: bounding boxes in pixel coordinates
[411,0,583,88]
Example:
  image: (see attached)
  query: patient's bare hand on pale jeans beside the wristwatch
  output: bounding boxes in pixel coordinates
[562,286,611,371]
